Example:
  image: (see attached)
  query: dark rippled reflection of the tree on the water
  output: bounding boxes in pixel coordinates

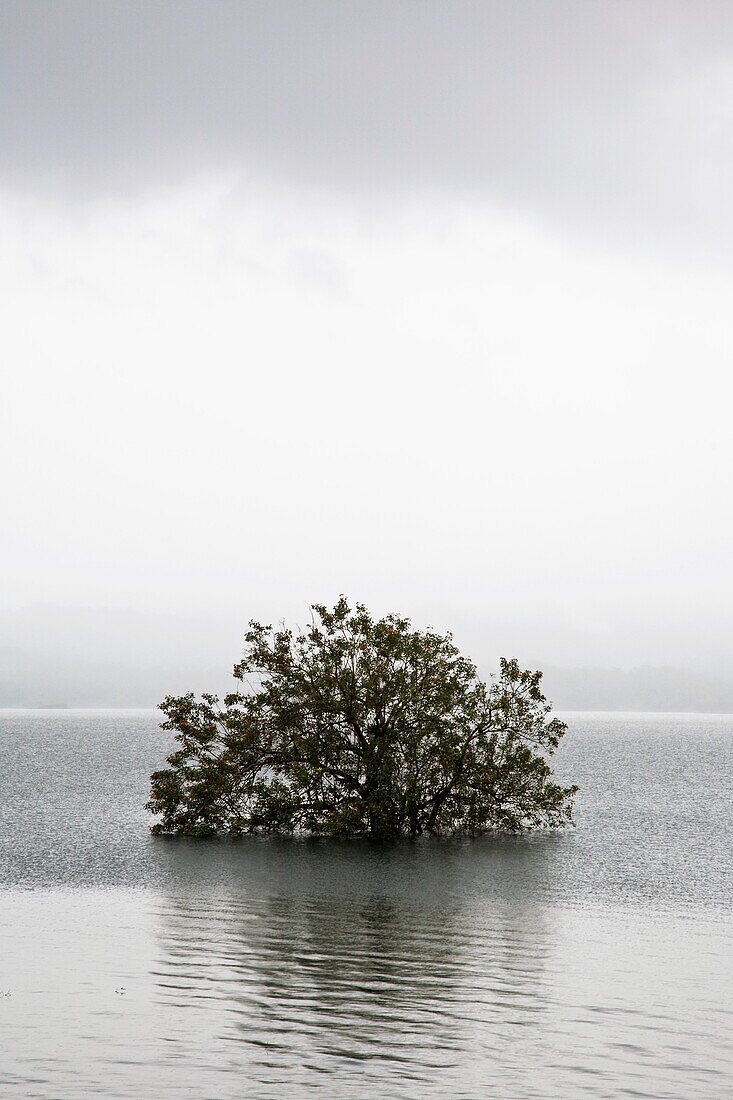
[150,844,549,1080]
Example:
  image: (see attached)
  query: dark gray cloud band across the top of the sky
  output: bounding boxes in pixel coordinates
[0,0,733,252]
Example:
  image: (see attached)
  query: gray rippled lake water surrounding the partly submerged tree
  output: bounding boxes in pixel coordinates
[0,711,733,1100]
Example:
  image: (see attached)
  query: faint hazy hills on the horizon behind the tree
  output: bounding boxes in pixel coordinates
[0,607,733,712]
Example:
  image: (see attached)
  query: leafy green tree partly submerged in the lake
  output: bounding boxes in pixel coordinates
[147,596,577,838]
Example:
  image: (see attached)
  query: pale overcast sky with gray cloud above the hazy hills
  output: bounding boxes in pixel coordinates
[0,0,733,673]
